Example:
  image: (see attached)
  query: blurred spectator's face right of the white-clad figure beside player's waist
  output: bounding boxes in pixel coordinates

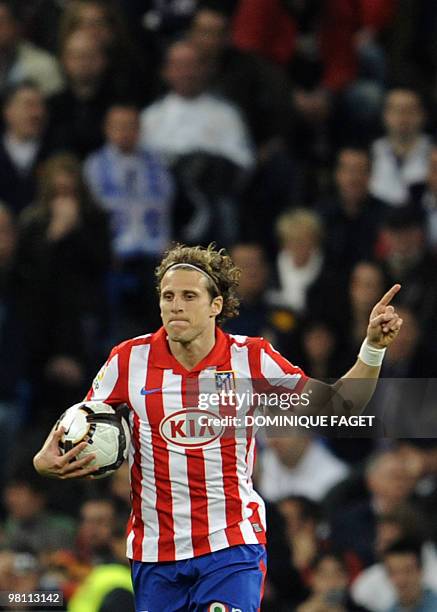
[367,452,416,512]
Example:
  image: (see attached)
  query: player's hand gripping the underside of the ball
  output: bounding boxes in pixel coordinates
[33,427,98,480]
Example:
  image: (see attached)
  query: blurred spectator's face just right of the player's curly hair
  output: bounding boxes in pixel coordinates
[231,244,268,302]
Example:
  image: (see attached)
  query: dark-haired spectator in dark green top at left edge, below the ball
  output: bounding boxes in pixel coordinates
[2,470,76,555]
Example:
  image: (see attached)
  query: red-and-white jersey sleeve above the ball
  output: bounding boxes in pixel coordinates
[85,346,128,406]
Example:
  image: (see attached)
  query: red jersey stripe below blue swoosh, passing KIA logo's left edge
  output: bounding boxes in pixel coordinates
[145,364,175,561]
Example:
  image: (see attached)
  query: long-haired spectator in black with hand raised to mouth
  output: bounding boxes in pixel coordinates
[17,154,110,425]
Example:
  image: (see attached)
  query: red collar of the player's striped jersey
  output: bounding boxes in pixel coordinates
[149,327,229,374]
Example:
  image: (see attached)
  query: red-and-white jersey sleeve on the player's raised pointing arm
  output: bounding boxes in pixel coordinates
[260,340,308,394]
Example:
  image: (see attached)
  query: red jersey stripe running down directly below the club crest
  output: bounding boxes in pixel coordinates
[217,352,244,546]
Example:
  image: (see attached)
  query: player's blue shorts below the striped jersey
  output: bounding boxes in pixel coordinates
[132,544,266,612]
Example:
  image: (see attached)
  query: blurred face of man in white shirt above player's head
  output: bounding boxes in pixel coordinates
[163,42,206,98]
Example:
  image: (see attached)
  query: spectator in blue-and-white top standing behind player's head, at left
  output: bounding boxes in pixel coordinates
[84,104,174,339]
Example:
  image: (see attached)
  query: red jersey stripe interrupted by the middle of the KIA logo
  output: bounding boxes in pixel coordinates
[182,376,211,556]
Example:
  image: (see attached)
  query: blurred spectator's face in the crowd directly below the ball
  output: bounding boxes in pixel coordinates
[79,499,115,547]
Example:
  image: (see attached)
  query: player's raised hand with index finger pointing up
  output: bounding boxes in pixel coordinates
[367,285,403,349]
